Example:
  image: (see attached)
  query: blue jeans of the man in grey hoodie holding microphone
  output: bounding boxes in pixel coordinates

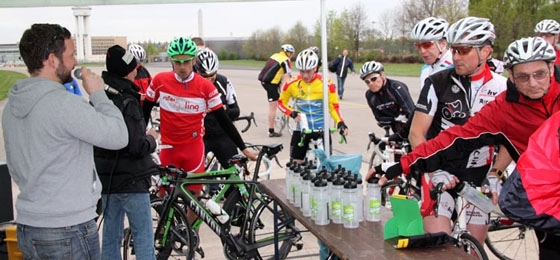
[17,219,100,260]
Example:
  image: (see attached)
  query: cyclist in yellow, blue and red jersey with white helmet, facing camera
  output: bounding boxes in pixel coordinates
[278,49,348,161]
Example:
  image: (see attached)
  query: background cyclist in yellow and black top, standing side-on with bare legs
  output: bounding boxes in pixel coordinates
[258,44,295,137]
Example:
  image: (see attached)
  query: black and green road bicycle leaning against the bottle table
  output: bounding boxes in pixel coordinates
[123,144,303,259]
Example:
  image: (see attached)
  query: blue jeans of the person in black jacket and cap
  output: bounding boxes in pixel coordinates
[101,193,155,260]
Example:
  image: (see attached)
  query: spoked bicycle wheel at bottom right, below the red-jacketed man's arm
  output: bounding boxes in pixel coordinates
[485,214,539,260]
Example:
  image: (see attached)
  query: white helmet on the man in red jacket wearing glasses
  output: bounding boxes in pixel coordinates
[504,37,556,69]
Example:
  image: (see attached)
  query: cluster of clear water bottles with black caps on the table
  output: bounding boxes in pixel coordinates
[286,157,381,228]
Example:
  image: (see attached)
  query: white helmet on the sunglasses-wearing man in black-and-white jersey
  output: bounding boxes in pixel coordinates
[446,16,496,45]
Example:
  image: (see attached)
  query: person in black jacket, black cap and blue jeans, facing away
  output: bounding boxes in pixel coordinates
[94,45,158,259]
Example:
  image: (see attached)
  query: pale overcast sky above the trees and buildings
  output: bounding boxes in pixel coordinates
[0,0,402,44]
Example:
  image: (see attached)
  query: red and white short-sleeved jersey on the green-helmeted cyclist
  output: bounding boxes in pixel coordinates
[146,71,223,145]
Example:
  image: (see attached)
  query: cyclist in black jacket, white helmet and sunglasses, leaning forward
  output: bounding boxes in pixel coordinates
[360,61,414,139]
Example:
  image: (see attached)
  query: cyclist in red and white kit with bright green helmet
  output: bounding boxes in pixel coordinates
[144,37,254,195]
